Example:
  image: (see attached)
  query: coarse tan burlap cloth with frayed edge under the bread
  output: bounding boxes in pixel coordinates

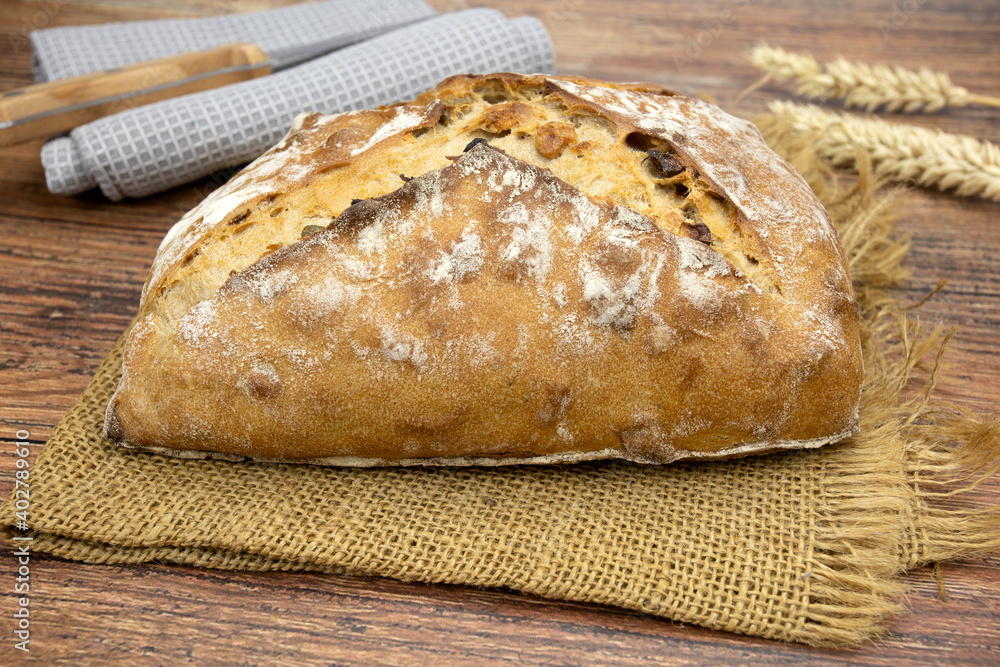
[0,118,1000,645]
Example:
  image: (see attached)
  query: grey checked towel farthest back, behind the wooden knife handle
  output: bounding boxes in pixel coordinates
[30,0,434,82]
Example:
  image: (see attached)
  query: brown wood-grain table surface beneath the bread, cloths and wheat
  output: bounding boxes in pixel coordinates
[0,0,1000,665]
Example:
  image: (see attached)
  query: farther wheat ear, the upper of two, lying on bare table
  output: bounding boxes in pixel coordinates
[750,44,1000,113]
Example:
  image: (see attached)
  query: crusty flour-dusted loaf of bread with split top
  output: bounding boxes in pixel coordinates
[105,74,862,466]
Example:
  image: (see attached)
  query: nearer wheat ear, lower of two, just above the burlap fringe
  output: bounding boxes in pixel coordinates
[768,100,1000,201]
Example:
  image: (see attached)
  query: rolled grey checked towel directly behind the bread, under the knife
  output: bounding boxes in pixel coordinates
[42,9,554,201]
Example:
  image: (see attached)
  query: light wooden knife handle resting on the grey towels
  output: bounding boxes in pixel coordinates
[0,43,271,146]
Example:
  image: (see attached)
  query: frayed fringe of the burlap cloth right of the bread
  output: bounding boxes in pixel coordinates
[755,115,1000,646]
